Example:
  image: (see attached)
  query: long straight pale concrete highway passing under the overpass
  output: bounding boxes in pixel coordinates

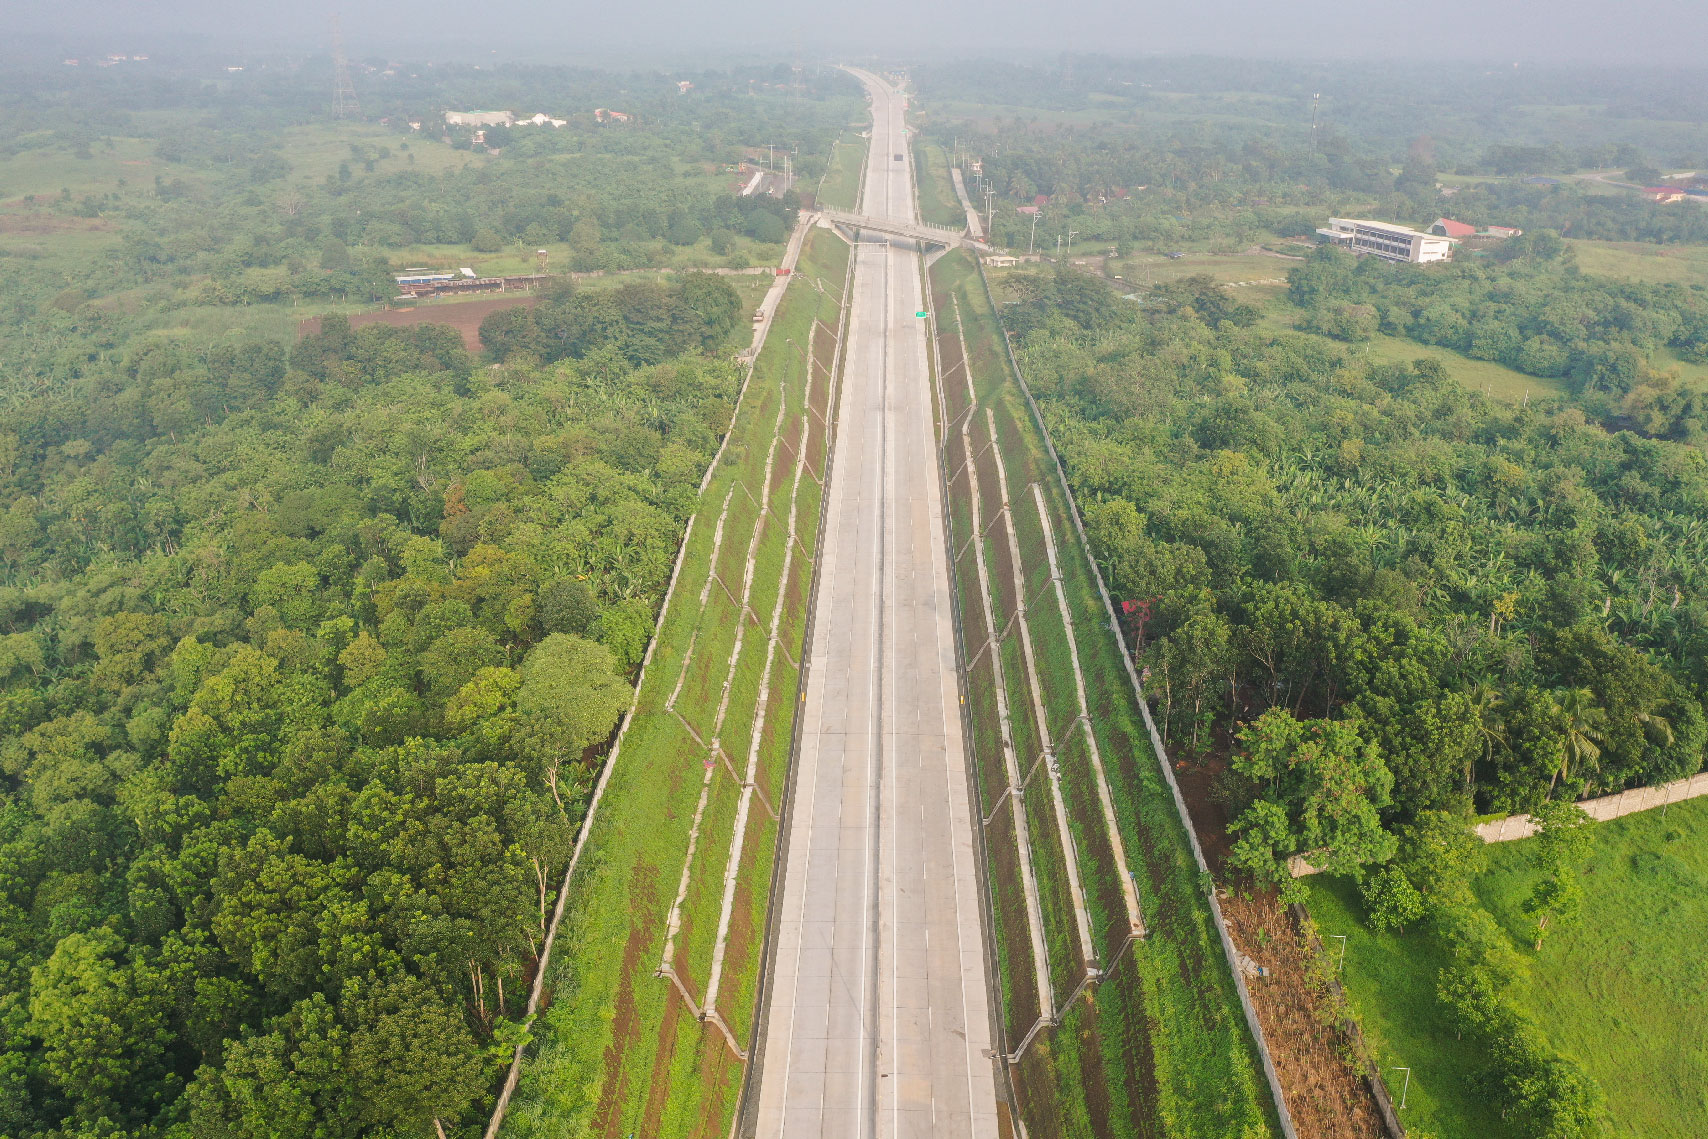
[753,72,997,1139]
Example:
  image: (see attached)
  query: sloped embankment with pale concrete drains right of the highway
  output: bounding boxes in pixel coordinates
[929,253,1278,1137]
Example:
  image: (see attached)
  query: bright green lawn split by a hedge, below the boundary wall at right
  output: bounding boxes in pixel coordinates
[1310,799,1708,1139]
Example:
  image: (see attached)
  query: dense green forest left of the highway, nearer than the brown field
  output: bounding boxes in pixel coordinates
[0,307,738,1136]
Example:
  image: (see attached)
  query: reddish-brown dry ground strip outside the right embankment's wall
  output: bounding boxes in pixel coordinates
[1221,891,1383,1139]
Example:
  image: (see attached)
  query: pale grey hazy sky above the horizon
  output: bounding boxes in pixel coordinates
[13,0,1708,65]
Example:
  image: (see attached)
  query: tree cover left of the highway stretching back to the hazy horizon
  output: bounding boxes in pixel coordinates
[0,44,826,1139]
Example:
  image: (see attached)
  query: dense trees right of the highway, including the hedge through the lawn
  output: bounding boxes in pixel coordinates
[1006,258,1708,1137]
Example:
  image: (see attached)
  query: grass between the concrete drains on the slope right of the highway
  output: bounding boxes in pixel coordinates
[931,253,1274,1139]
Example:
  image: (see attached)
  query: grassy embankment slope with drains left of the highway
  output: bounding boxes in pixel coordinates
[506,231,849,1137]
